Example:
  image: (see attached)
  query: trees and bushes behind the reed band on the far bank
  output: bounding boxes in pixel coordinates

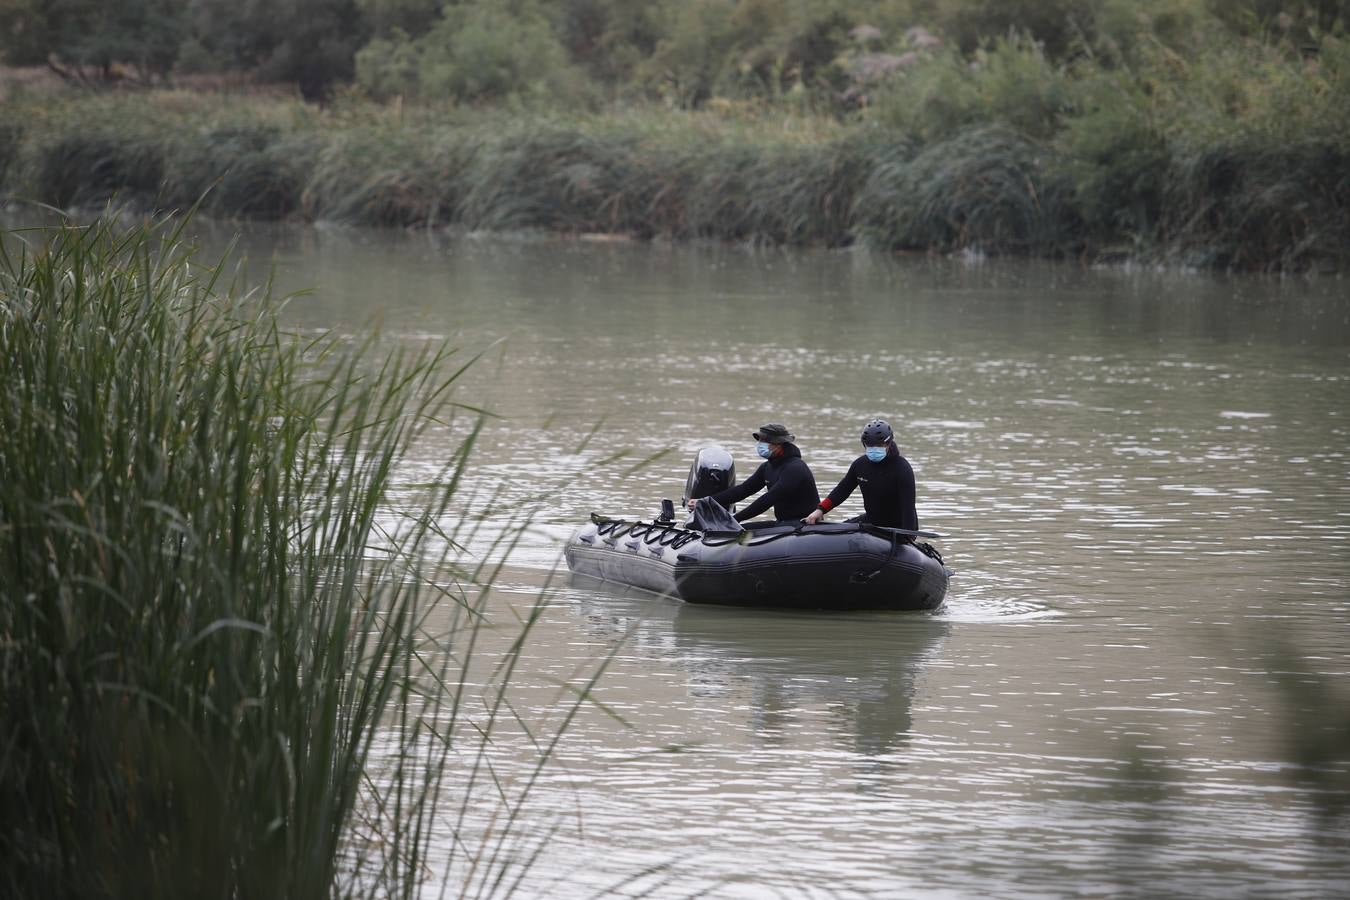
[0,0,1350,107]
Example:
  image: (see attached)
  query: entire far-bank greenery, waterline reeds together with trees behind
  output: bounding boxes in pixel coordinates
[0,0,1350,270]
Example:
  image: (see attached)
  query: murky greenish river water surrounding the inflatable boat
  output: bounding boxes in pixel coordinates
[216,227,1350,897]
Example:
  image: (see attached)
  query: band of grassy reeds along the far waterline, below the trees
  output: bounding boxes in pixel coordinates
[0,22,1350,271]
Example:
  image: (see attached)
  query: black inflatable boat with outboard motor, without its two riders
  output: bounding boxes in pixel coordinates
[566,448,952,610]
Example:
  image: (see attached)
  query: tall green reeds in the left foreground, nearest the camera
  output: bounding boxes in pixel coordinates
[0,214,575,897]
